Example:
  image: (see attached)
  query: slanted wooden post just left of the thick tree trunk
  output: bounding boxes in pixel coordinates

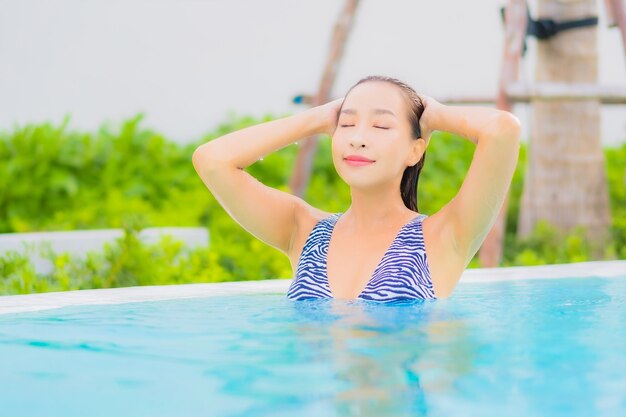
[478,0,527,268]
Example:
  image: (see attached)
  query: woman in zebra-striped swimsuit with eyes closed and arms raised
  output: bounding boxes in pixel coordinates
[193,76,520,301]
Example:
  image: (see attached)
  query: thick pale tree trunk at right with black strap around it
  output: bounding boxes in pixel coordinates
[518,0,611,259]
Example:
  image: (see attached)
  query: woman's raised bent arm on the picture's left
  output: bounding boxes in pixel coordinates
[193,100,341,254]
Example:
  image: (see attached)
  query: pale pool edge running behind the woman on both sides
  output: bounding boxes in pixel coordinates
[0,260,626,314]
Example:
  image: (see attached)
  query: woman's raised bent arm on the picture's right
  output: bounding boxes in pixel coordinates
[420,97,520,266]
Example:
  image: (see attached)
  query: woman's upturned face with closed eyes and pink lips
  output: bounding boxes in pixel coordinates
[332,81,423,187]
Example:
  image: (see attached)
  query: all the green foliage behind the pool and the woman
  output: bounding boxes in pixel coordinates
[0,115,626,294]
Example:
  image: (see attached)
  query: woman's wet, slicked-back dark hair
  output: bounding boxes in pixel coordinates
[338,75,426,212]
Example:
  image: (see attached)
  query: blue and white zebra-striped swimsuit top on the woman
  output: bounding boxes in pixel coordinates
[287,213,436,302]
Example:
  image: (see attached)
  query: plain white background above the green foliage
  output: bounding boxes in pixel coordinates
[0,0,626,143]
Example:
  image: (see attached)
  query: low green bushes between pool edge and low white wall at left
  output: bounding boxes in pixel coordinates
[0,229,234,294]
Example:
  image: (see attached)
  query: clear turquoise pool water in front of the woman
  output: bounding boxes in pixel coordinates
[0,276,626,417]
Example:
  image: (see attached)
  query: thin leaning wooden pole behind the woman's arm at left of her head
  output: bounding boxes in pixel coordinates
[289,0,359,197]
